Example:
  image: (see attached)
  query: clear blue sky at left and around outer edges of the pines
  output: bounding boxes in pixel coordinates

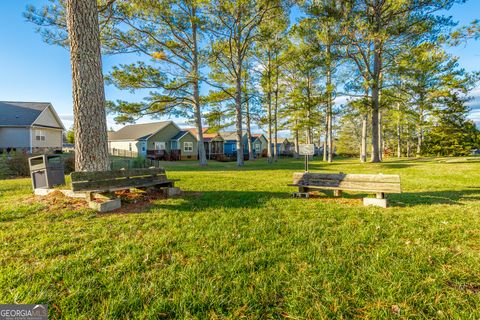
[0,0,480,128]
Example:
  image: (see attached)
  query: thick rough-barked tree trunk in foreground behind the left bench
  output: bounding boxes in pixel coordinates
[66,0,109,171]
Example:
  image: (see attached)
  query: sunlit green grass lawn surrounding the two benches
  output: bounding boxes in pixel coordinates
[0,158,480,319]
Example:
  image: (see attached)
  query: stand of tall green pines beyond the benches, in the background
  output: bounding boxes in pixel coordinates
[25,0,480,165]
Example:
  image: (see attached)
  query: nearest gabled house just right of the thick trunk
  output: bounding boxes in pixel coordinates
[108,121,198,160]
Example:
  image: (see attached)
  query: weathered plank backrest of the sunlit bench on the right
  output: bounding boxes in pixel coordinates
[293,172,402,193]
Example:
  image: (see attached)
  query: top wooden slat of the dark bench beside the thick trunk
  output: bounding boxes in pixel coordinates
[70,168,165,182]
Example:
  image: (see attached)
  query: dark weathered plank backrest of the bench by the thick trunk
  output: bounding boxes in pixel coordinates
[70,168,167,191]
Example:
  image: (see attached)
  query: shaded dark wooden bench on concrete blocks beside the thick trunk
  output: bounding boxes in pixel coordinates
[70,168,178,212]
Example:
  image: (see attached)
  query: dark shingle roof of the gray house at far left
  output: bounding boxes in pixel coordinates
[0,101,50,126]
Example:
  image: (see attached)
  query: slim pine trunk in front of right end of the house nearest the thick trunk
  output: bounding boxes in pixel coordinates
[192,12,207,167]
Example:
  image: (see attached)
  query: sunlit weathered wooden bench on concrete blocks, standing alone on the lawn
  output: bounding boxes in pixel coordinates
[289,172,402,208]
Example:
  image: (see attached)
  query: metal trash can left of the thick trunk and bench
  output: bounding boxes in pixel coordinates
[28,154,65,190]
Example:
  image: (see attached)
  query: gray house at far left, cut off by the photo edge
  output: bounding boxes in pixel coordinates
[0,101,65,153]
